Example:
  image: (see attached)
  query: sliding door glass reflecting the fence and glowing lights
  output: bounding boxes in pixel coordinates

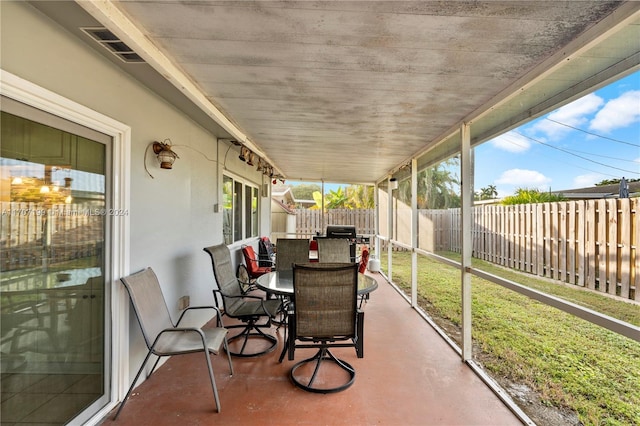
[0,111,109,425]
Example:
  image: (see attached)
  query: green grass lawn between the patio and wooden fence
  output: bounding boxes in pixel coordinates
[382,252,640,425]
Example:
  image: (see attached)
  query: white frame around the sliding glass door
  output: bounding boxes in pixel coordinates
[0,69,131,424]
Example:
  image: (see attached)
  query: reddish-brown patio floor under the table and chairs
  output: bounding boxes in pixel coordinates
[104,275,521,426]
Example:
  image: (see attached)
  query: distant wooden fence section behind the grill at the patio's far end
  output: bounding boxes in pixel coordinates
[296,209,376,238]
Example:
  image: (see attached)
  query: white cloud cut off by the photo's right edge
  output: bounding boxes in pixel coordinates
[589,90,640,132]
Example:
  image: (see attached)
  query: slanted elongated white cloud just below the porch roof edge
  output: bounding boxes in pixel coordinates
[531,93,604,139]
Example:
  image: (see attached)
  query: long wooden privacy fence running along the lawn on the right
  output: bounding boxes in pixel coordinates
[419,198,640,301]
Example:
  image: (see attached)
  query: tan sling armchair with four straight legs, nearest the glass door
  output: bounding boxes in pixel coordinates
[113,268,233,420]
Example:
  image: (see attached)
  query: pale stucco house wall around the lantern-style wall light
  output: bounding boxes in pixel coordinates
[0,2,270,398]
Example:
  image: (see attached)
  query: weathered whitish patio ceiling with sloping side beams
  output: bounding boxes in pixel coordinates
[31,0,640,183]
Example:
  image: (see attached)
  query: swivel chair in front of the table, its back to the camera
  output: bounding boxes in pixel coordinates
[288,263,364,393]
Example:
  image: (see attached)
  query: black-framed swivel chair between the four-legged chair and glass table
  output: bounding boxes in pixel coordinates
[204,244,282,357]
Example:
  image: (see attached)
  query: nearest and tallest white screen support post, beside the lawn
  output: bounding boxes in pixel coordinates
[460,123,473,361]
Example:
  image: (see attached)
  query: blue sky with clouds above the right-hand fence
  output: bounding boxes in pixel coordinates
[475,71,640,196]
